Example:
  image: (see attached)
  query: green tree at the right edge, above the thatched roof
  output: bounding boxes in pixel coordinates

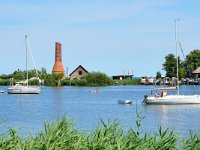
[186,50,200,72]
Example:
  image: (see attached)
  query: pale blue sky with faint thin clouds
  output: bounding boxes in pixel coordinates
[0,0,200,77]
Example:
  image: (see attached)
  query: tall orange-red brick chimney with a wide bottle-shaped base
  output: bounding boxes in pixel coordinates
[52,42,65,77]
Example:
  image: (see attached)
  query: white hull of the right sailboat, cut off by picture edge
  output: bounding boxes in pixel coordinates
[143,95,200,105]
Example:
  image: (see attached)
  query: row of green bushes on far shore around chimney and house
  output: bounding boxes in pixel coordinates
[0,68,113,86]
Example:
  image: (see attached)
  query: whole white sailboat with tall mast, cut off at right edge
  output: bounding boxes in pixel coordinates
[143,20,200,105]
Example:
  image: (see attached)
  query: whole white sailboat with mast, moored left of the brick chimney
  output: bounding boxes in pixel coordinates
[8,35,41,94]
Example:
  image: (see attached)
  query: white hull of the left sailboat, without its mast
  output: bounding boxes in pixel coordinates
[8,86,41,94]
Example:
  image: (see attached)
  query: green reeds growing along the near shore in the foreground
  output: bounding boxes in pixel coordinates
[0,115,200,150]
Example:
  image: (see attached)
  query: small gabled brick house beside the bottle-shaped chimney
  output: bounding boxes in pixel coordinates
[69,65,88,80]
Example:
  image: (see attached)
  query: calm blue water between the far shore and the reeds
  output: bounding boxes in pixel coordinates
[0,86,200,135]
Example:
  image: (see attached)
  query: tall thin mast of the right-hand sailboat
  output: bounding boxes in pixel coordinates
[175,19,179,95]
